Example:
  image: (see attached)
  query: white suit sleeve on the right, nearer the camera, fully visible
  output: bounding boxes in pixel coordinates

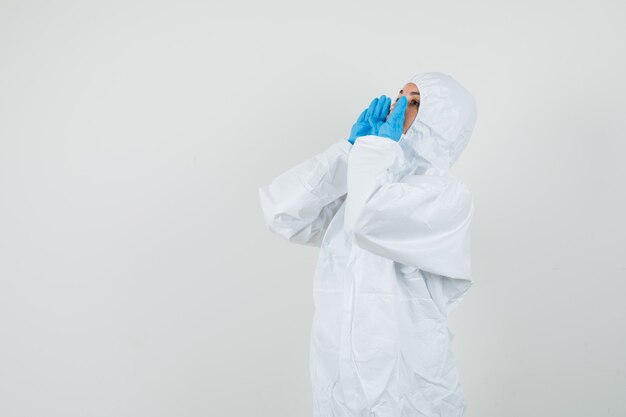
[346,136,474,280]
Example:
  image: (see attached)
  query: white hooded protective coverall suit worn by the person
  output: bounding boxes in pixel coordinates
[259,72,477,417]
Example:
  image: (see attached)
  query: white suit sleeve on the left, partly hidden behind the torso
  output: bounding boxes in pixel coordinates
[259,140,352,247]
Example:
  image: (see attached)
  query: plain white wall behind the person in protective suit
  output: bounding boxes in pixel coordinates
[0,0,626,417]
